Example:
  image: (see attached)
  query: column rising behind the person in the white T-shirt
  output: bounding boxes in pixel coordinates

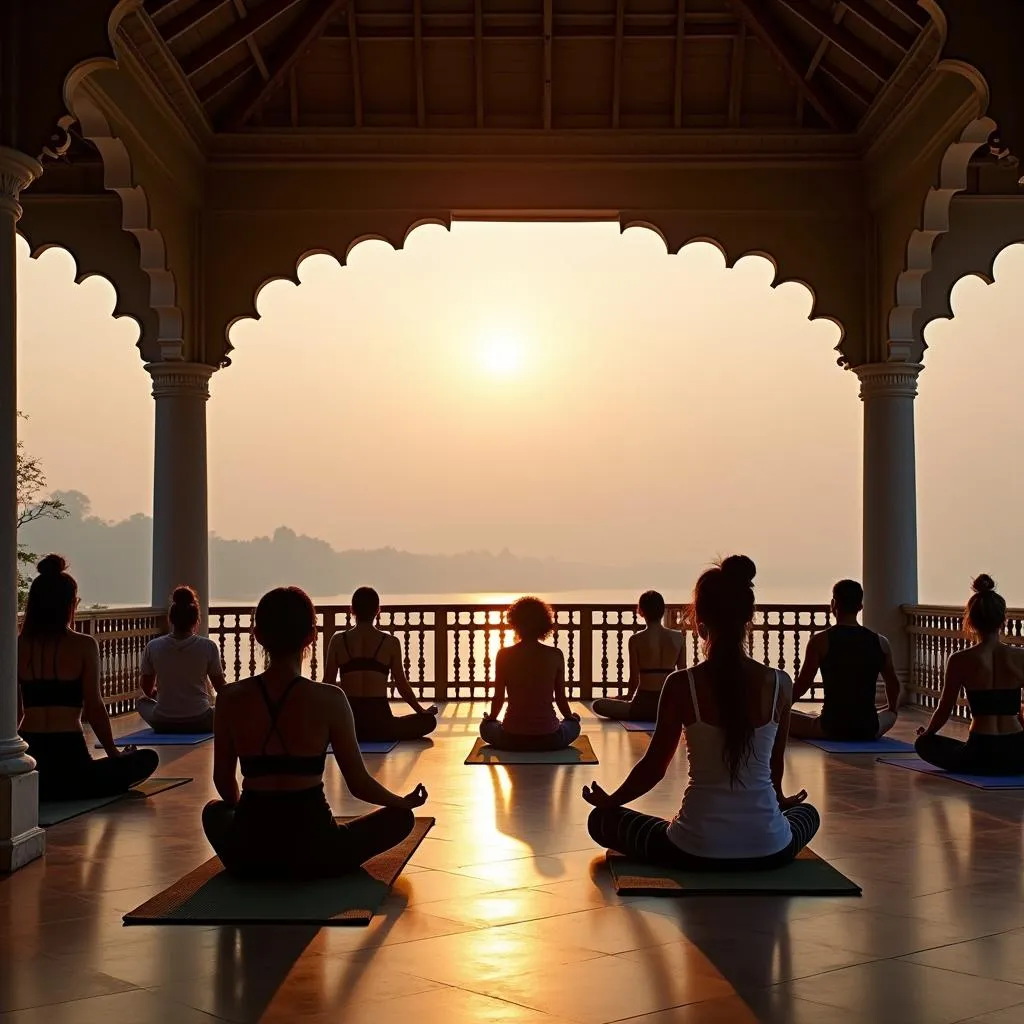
[145,359,213,632]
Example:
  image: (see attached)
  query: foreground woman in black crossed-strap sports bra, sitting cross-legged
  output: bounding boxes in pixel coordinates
[203,587,427,879]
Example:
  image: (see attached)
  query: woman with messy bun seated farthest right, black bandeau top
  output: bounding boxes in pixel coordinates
[914,575,1024,775]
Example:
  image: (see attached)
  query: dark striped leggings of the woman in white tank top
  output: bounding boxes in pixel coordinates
[587,804,821,871]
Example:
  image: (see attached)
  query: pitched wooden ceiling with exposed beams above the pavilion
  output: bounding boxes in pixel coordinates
[144,0,927,132]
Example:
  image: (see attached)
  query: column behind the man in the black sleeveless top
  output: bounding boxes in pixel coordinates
[855,362,922,685]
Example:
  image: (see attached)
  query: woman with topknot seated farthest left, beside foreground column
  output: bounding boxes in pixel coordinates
[17,555,160,801]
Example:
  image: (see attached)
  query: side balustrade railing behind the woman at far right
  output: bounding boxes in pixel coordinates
[903,605,1024,722]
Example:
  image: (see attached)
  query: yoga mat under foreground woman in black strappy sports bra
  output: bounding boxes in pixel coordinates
[123,818,434,925]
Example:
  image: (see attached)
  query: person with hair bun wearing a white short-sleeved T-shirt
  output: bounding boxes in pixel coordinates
[138,587,224,733]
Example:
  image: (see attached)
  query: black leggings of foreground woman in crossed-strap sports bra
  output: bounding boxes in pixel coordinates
[203,783,416,879]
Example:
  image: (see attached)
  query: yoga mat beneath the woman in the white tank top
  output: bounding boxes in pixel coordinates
[607,848,860,896]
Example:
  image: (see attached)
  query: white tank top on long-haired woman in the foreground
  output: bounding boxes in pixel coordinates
[669,669,793,859]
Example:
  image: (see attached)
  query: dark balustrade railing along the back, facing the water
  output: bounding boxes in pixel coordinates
[209,604,830,700]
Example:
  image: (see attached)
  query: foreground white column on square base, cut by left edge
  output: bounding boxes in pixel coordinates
[0,146,46,871]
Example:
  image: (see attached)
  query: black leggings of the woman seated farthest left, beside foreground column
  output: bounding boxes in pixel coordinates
[22,729,160,801]
